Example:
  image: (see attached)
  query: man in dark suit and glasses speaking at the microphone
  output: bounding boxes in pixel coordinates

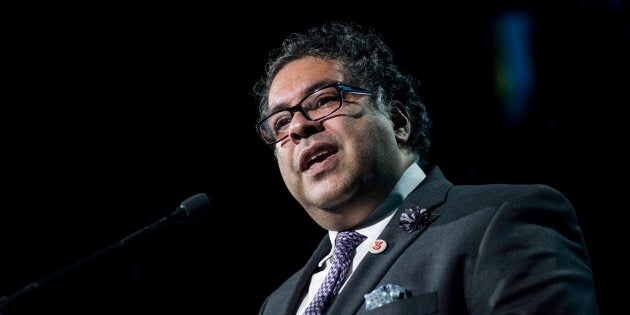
[254,22,598,315]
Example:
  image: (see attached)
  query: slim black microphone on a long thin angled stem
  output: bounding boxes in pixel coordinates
[0,193,210,315]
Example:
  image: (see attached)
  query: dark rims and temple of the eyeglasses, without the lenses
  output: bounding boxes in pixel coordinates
[256,82,374,145]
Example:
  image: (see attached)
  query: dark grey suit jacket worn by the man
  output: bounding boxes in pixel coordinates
[259,167,598,315]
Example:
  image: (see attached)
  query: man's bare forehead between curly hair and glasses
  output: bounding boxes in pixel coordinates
[269,56,344,108]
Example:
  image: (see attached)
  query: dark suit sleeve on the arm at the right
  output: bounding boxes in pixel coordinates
[468,185,598,315]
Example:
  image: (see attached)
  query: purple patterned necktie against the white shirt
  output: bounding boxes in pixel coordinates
[304,231,367,315]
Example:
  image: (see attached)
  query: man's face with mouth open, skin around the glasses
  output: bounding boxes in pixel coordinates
[269,57,401,229]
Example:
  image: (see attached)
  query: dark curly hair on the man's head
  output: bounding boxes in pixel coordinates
[253,21,431,167]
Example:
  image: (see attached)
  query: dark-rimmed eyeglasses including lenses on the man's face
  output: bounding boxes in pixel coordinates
[256,82,374,144]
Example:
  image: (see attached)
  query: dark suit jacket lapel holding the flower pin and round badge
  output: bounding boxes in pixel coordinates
[328,166,453,315]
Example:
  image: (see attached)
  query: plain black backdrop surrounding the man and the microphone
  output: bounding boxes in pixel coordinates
[0,0,630,315]
